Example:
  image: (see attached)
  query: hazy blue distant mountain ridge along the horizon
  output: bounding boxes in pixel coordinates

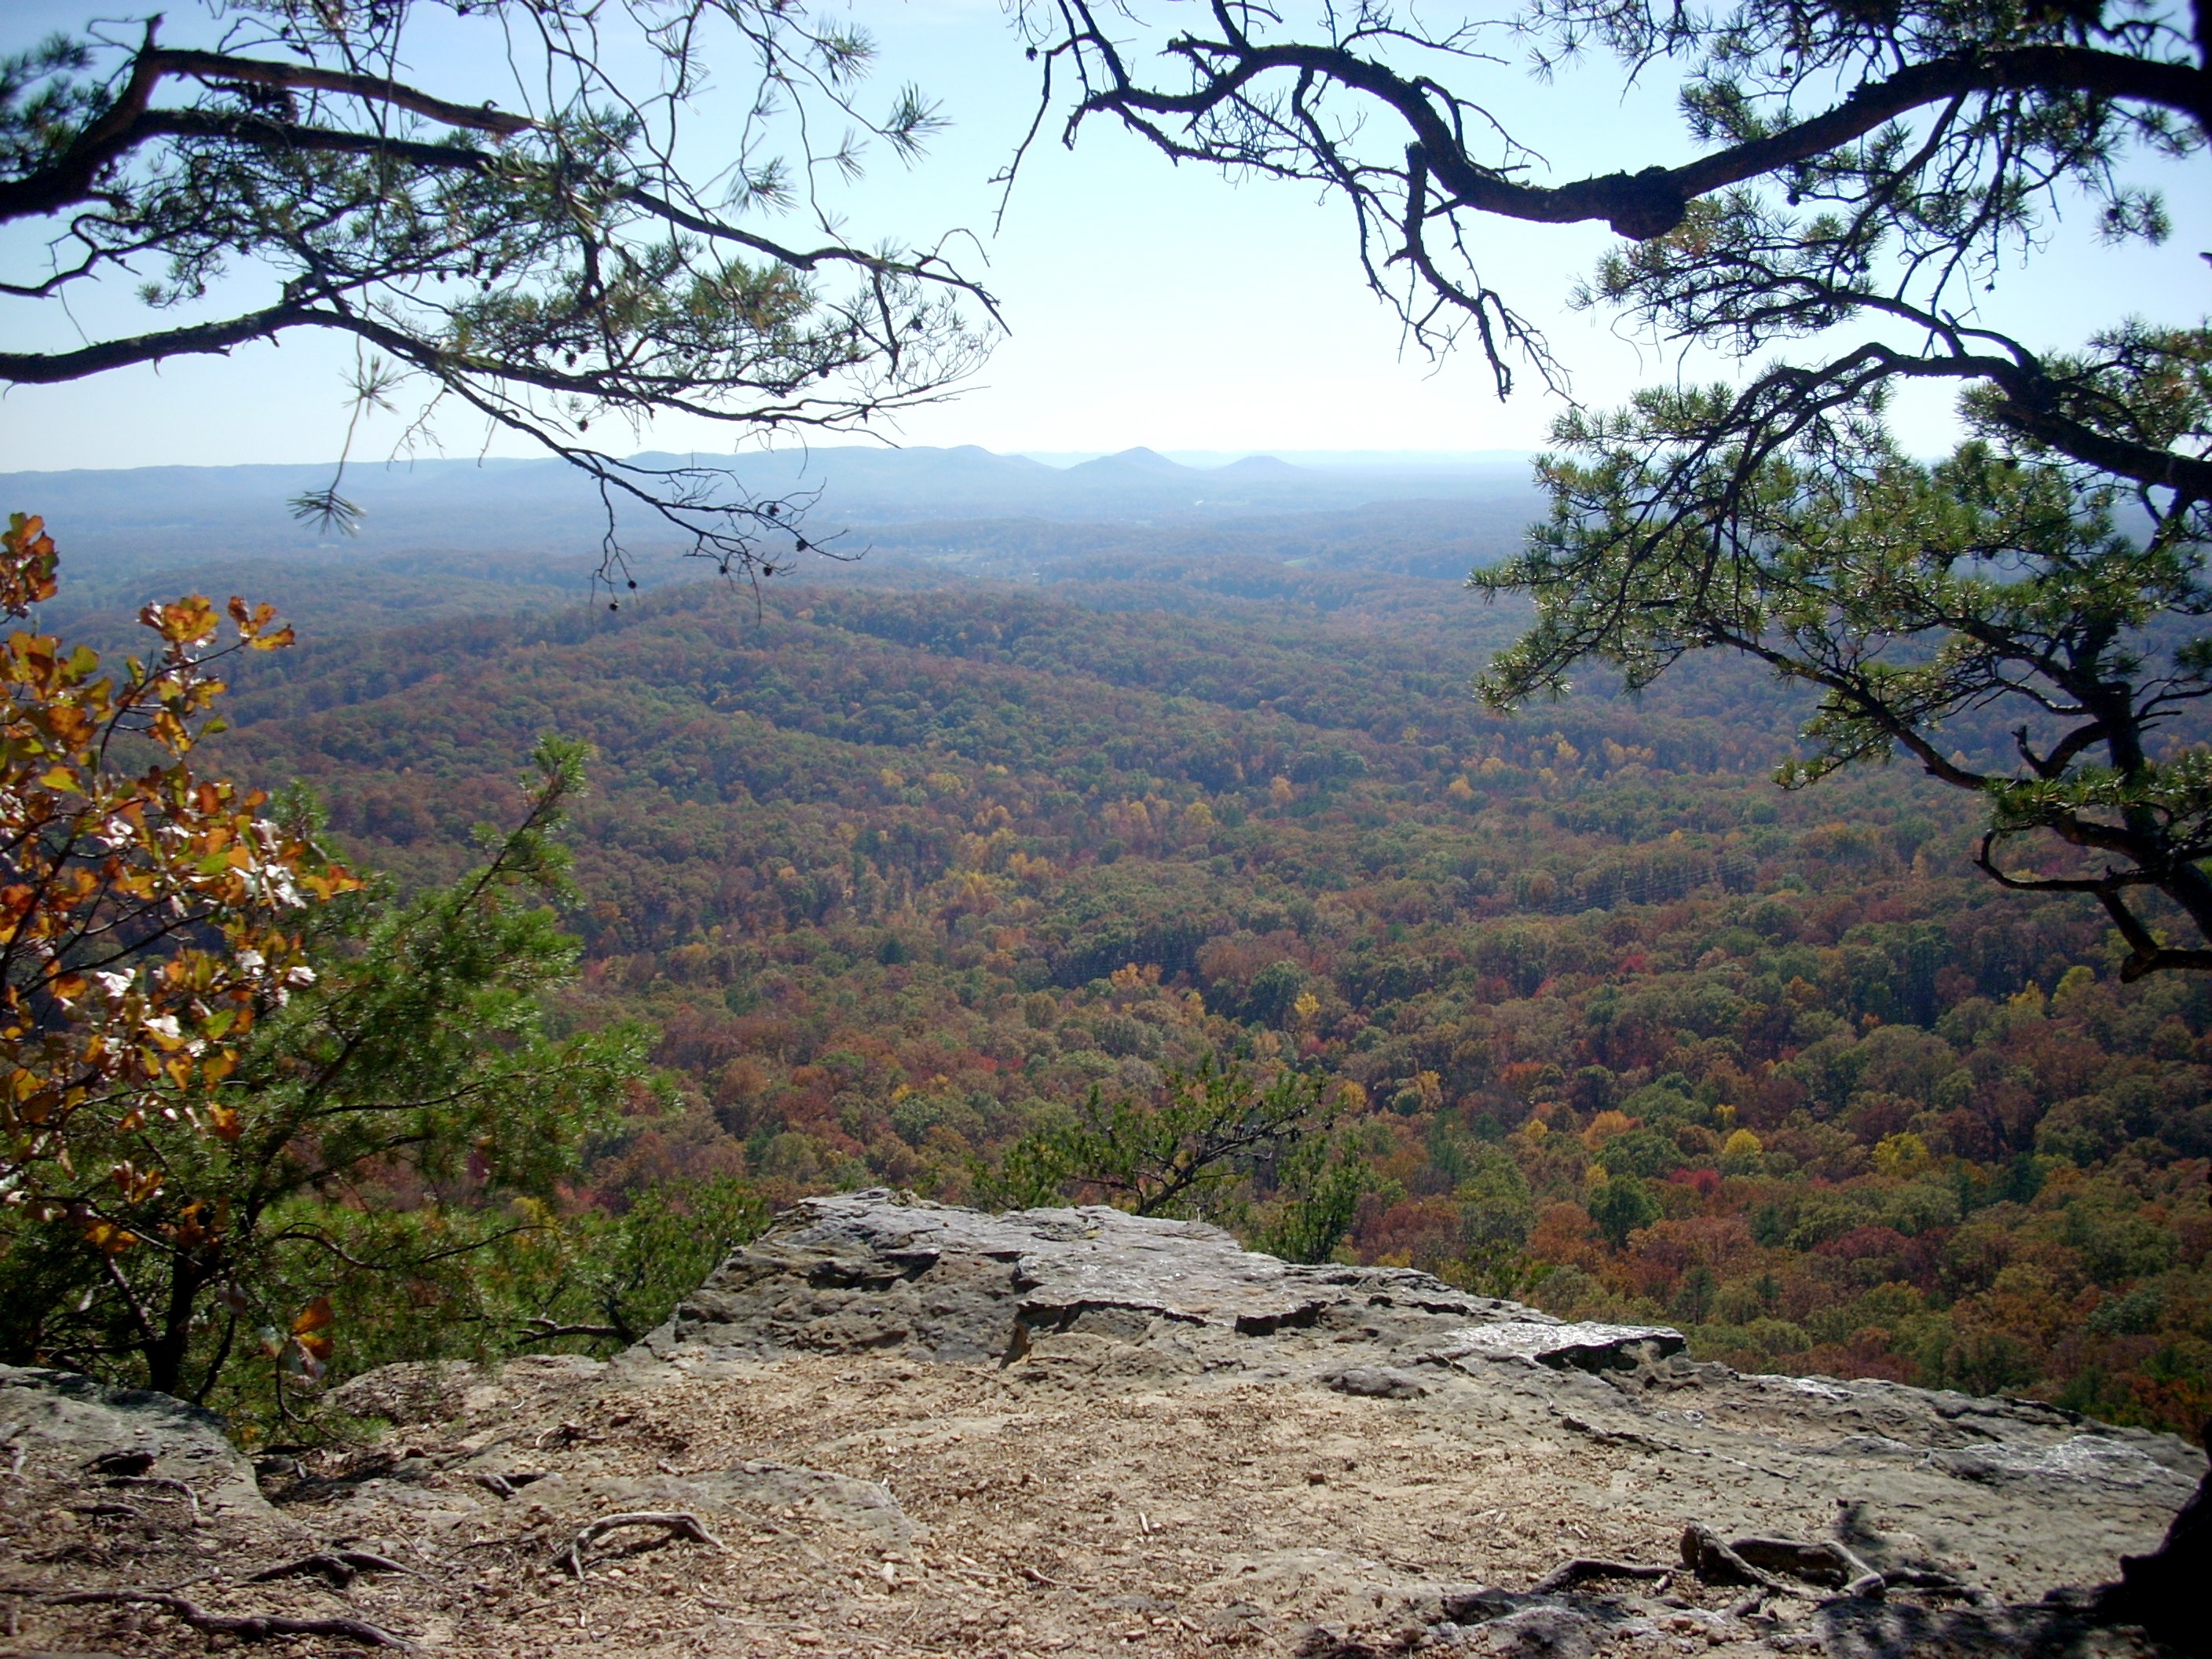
[0,445,1533,575]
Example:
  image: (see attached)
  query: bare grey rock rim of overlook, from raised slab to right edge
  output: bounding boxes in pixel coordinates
[613,1190,2206,1659]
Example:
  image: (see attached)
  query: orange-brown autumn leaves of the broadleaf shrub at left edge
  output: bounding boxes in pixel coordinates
[0,513,361,1254]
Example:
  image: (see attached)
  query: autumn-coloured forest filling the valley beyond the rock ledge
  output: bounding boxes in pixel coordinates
[38,524,2212,1431]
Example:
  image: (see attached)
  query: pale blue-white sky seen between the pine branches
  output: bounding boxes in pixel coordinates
[0,0,2212,471]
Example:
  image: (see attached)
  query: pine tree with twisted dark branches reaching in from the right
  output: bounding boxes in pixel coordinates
[1020,0,2212,976]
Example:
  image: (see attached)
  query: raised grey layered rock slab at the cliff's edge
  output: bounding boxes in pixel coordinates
[643,1188,1683,1391]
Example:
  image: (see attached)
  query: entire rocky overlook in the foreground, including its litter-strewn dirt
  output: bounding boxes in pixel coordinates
[5,1192,2206,1659]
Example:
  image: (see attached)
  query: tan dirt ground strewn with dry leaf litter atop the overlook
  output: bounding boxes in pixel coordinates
[0,1356,2176,1659]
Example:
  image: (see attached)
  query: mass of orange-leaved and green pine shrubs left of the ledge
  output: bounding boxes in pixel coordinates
[0,518,672,1426]
